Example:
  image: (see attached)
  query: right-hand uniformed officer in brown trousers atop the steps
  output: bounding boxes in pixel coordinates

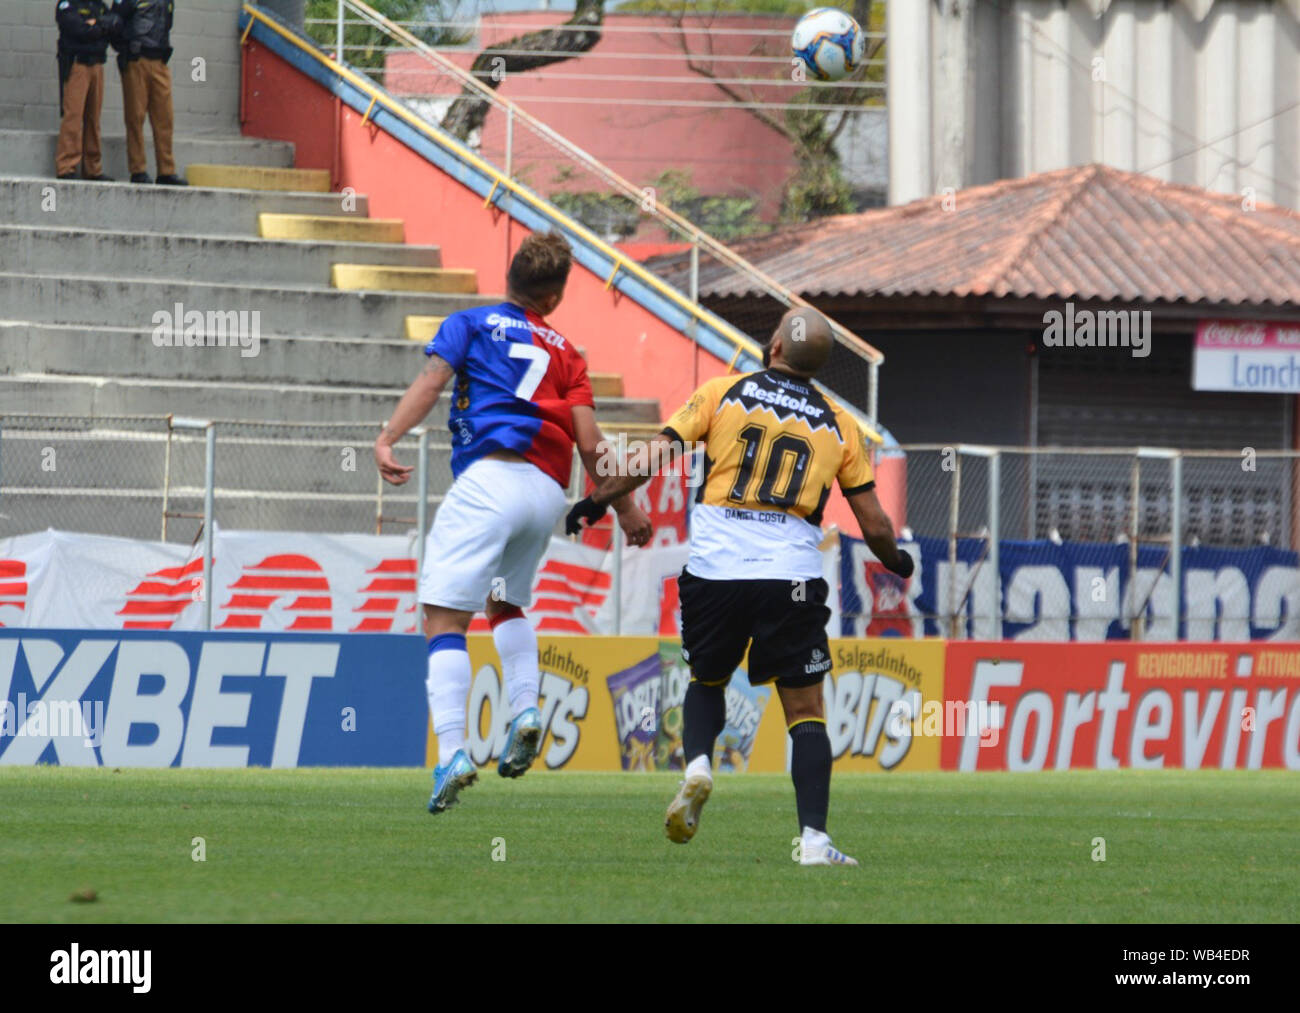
[113,0,186,186]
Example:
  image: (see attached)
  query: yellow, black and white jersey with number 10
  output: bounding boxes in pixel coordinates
[664,369,874,580]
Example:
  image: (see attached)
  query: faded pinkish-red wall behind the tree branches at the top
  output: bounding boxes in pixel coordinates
[385,10,800,220]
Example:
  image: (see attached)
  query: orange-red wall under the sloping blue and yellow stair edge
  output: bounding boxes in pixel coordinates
[243,39,857,533]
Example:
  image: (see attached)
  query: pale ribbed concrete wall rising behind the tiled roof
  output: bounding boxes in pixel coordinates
[887,0,1300,208]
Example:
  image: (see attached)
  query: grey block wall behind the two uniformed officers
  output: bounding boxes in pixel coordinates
[0,0,241,135]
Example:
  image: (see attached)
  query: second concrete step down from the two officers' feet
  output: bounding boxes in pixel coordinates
[0,225,441,291]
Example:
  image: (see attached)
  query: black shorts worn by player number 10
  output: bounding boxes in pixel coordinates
[677,570,831,689]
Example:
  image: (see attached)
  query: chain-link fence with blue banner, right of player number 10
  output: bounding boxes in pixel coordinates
[873,445,1300,640]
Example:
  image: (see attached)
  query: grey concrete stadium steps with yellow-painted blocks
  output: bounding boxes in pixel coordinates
[0,130,659,541]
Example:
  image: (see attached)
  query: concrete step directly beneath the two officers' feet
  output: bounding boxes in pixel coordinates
[0,177,369,242]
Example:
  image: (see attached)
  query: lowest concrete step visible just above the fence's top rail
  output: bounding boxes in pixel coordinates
[0,374,659,429]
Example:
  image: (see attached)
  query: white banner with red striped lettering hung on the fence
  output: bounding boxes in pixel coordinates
[0,528,702,636]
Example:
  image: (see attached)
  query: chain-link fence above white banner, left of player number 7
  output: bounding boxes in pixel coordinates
[0,415,441,544]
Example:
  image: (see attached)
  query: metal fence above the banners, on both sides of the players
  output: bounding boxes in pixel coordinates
[0,414,1300,559]
